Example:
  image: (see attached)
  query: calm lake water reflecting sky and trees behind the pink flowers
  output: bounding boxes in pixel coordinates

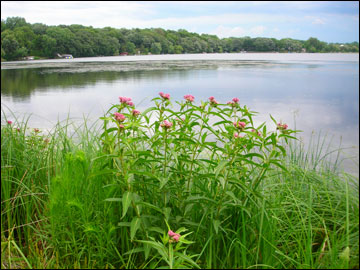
[1,53,359,174]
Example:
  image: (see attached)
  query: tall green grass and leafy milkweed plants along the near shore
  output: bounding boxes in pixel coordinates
[1,98,359,269]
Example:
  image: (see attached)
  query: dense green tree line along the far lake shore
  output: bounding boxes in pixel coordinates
[1,17,359,61]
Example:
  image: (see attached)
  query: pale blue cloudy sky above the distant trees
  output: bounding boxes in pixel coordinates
[1,1,359,43]
